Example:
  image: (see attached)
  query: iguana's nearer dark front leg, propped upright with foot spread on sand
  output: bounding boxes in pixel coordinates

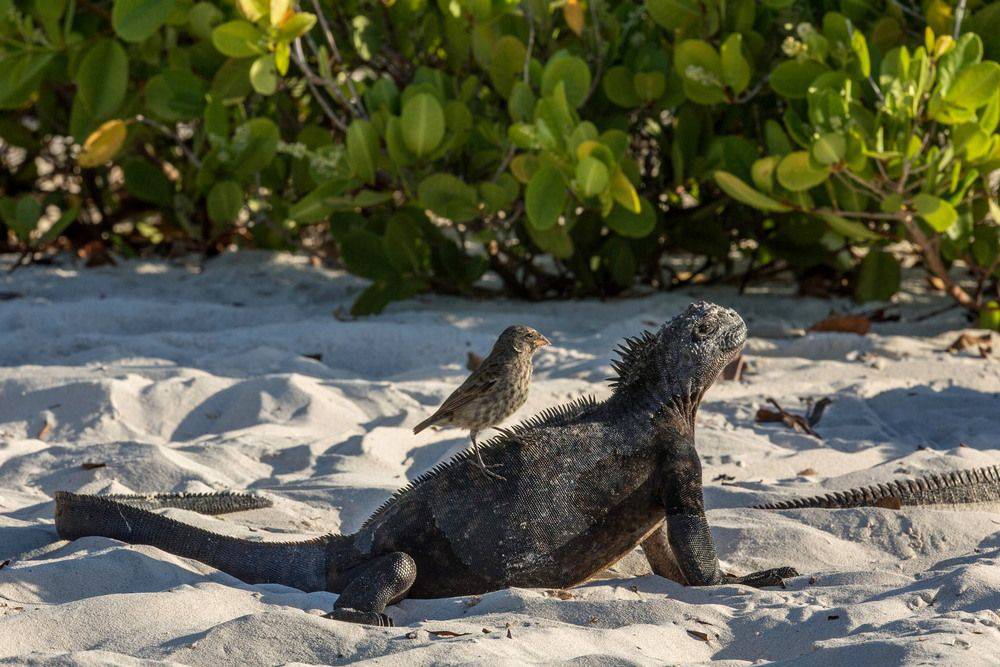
[663,447,798,587]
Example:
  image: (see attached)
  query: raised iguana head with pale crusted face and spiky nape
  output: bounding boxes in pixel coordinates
[612,301,747,416]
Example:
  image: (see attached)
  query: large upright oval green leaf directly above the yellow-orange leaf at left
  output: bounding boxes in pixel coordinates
[69,39,128,142]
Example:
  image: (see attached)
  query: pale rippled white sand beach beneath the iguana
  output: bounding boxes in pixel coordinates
[0,253,1000,666]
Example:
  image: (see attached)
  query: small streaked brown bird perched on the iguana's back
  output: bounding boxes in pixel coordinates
[413,325,549,479]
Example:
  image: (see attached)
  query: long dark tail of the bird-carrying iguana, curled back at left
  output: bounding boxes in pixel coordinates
[55,491,335,591]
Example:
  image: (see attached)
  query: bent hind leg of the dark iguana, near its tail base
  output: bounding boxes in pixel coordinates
[325,551,417,626]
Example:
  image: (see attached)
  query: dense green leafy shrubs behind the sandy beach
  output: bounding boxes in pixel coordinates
[0,0,1000,328]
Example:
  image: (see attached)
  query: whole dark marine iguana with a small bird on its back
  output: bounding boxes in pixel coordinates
[56,302,1000,625]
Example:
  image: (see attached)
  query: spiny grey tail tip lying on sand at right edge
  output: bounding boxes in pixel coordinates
[753,465,1000,510]
